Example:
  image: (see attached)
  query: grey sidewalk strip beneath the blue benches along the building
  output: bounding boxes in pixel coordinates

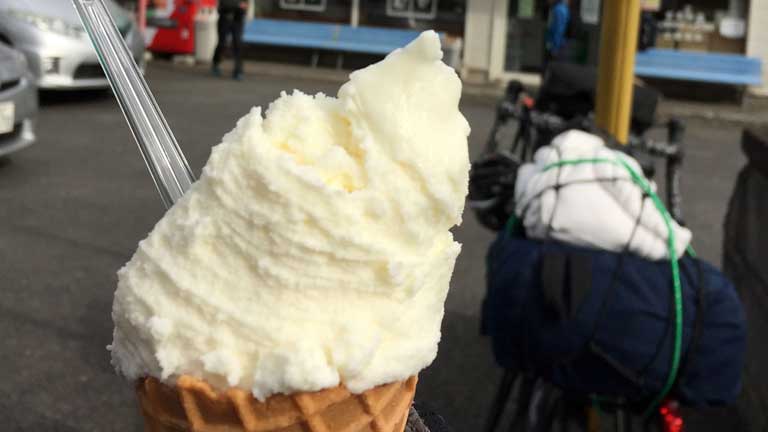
[214,57,768,126]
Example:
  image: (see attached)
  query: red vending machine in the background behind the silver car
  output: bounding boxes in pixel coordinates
[144,0,217,55]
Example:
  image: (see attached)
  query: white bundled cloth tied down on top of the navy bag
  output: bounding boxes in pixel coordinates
[515,130,691,260]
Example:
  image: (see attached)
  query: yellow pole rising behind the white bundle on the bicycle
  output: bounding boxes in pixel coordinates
[595,0,640,144]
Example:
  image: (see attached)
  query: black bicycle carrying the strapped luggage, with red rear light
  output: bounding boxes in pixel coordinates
[476,63,685,432]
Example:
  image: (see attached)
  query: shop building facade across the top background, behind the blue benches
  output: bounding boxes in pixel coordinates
[119,0,768,96]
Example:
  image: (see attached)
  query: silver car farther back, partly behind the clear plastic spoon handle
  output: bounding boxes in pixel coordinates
[0,0,144,89]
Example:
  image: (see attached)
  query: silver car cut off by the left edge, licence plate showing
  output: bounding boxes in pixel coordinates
[0,43,37,156]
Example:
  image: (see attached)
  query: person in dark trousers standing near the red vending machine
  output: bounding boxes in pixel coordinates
[211,0,248,80]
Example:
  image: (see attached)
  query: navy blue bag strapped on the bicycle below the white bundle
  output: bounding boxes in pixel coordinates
[483,232,746,406]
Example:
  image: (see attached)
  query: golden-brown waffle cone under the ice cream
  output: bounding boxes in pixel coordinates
[136,376,416,432]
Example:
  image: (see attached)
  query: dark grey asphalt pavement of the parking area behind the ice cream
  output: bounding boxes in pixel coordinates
[0,61,744,432]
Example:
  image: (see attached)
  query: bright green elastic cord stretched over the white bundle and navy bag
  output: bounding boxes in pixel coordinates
[544,155,684,417]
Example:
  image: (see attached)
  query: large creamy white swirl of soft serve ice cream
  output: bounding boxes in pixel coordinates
[110,32,469,399]
